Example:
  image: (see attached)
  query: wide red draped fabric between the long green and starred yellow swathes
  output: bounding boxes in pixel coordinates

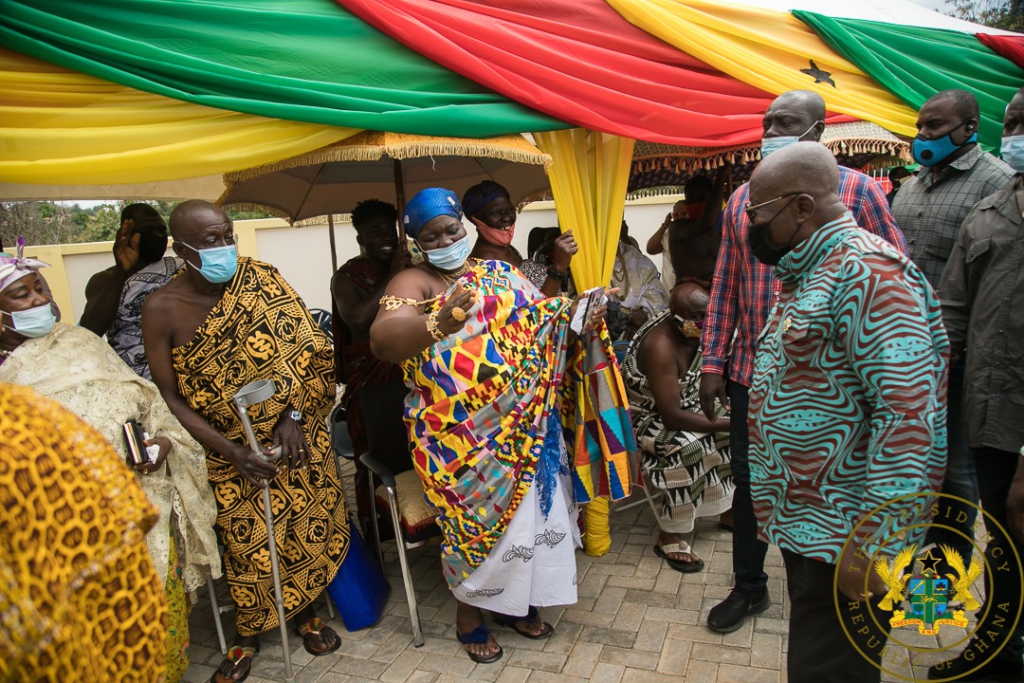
[338,0,852,146]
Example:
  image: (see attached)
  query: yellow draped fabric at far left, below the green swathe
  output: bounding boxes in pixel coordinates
[0,49,359,185]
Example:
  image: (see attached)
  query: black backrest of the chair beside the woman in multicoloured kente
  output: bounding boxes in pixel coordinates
[359,379,413,474]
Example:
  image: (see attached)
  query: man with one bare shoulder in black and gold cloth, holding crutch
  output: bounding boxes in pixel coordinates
[142,200,348,683]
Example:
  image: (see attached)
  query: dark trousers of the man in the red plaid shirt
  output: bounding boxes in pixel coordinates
[728,382,768,593]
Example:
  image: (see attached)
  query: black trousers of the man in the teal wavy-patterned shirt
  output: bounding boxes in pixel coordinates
[782,550,895,683]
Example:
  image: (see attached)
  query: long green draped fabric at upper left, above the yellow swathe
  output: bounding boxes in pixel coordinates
[0,0,567,137]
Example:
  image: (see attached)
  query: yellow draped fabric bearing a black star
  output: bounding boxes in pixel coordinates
[608,0,918,137]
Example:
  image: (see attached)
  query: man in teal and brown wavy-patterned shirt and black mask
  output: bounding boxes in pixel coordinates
[746,142,949,683]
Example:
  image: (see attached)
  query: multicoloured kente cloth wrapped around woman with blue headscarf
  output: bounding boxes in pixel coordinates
[402,261,636,590]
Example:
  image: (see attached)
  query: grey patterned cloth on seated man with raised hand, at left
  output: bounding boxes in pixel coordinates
[106,256,184,380]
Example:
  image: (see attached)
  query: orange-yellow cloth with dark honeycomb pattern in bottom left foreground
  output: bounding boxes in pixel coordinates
[0,384,167,683]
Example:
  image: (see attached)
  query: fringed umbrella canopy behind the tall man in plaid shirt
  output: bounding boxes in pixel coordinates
[629,121,913,199]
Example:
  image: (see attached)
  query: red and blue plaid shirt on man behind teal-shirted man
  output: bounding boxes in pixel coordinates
[700,166,906,387]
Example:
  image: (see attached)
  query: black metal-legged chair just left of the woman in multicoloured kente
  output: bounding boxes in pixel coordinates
[359,380,440,647]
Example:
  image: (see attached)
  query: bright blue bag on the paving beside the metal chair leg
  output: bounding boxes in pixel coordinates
[327,518,391,633]
